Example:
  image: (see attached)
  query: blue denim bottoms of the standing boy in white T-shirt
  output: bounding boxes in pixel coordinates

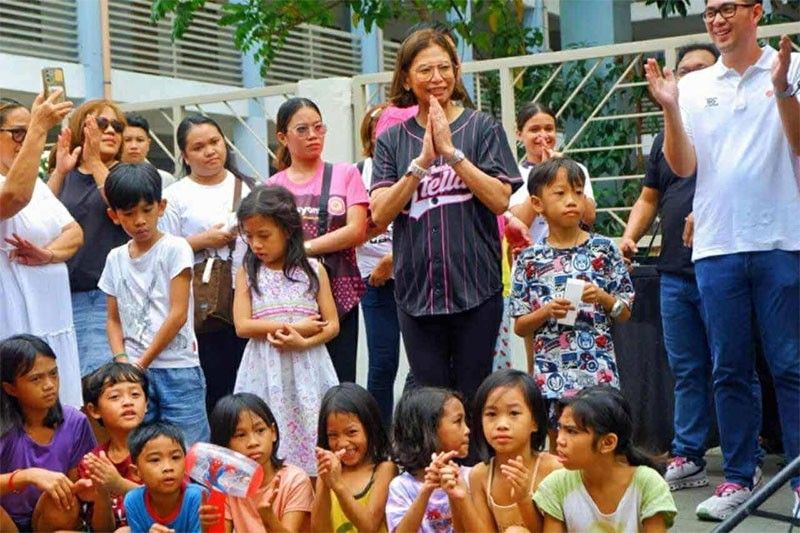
[144,366,211,448]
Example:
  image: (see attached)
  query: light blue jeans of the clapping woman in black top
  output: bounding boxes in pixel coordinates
[72,290,114,377]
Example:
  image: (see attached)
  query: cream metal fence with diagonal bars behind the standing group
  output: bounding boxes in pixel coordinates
[124,23,800,242]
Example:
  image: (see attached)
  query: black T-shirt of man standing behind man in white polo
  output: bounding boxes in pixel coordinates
[642,132,697,276]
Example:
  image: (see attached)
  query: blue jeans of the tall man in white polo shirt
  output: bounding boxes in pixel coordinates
[695,250,800,488]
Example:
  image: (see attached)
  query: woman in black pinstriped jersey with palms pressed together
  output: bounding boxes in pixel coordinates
[372,29,522,444]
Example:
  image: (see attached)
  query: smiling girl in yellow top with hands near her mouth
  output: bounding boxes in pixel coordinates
[311,383,397,533]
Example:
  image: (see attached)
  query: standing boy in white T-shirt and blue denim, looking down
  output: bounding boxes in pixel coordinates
[98,163,209,446]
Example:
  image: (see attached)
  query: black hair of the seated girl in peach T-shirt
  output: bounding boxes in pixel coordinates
[208,392,283,470]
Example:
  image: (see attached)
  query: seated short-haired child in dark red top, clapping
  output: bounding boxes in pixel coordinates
[78,362,147,531]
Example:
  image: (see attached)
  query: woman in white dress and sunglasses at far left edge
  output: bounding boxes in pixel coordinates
[0,92,83,407]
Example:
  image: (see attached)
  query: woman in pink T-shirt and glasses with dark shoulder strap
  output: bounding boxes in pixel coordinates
[267,98,369,382]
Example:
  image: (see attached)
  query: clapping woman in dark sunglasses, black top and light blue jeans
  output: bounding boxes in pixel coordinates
[47,100,128,376]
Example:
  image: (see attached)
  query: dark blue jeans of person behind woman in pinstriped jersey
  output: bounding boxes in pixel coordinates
[361,280,400,431]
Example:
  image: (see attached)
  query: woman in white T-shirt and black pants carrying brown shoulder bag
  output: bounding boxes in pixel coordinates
[159,115,254,411]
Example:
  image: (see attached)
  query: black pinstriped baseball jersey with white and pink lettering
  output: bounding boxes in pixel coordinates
[371,109,522,316]
